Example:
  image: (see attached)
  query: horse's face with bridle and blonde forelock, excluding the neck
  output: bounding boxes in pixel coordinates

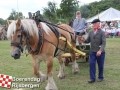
[7,19,25,59]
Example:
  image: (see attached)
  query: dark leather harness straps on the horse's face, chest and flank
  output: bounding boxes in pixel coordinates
[11,21,72,56]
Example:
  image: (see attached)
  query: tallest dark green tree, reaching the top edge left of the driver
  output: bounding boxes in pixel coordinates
[60,0,79,22]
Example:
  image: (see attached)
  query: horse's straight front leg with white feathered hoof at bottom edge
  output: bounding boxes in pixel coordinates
[45,57,58,90]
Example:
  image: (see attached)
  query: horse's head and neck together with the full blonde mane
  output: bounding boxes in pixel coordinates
[7,19,39,59]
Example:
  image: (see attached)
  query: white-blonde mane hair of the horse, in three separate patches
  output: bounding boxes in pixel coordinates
[7,19,50,39]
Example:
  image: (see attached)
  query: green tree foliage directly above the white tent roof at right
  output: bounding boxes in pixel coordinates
[87,0,120,18]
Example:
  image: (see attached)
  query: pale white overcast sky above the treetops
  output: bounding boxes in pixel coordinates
[0,0,100,19]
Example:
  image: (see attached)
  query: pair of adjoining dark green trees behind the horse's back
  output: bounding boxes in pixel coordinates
[43,0,79,23]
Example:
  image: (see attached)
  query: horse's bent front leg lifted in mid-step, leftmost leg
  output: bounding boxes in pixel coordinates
[33,58,47,82]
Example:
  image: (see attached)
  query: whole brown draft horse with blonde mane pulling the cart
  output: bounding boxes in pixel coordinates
[7,19,79,90]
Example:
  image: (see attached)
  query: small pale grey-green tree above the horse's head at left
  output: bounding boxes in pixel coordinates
[8,10,24,20]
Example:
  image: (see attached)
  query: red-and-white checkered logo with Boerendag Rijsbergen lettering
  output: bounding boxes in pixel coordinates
[0,74,41,90]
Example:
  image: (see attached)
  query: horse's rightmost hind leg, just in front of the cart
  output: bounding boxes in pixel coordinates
[70,45,79,74]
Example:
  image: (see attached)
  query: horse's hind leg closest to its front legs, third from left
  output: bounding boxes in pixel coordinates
[58,56,65,79]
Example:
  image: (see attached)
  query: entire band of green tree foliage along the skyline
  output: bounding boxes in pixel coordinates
[0,0,120,24]
